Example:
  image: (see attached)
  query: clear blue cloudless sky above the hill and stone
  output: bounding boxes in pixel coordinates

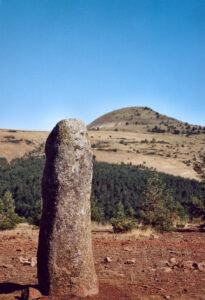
[0,0,205,130]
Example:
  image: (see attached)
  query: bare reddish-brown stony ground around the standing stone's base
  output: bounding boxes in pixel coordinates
[0,226,205,300]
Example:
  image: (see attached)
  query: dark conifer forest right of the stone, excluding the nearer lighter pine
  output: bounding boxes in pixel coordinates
[92,163,202,220]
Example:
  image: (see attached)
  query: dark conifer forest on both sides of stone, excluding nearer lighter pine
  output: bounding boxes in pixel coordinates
[0,157,204,226]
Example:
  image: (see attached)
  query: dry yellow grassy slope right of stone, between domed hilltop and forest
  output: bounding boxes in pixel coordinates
[89,131,204,180]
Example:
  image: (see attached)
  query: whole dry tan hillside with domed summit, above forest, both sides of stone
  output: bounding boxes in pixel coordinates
[0,107,205,179]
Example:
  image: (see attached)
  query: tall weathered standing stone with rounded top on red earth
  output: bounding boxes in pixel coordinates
[37,119,98,297]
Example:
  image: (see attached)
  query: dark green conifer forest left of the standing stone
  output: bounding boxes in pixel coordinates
[0,157,45,222]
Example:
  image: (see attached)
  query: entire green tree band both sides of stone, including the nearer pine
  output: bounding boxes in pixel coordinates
[0,157,205,229]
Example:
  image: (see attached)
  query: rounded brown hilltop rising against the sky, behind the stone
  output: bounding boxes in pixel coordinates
[88,106,205,136]
